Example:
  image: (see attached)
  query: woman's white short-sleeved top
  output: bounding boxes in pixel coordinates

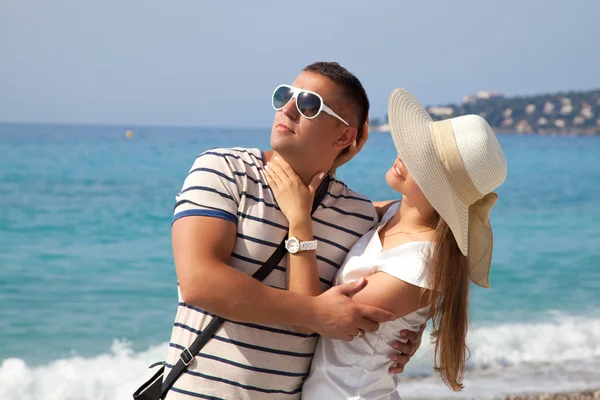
[302,204,431,400]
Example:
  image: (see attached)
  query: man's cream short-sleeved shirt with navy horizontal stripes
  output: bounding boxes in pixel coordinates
[166,148,377,400]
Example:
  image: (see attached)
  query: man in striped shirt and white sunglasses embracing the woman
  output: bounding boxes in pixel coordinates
[165,63,421,399]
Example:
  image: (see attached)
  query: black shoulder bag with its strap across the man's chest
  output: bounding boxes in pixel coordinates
[133,175,329,400]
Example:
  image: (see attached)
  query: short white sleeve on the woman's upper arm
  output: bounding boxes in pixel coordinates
[377,242,430,289]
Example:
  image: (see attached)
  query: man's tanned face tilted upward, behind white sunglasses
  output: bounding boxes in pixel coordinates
[271,72,349,163]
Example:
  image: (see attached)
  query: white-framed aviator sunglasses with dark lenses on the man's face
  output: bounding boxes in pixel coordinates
[272,85,350,126]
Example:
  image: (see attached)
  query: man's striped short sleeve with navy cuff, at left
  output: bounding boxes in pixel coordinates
[173,149,240,223]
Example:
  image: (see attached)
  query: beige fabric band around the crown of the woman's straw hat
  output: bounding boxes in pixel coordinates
[432,119,483,206]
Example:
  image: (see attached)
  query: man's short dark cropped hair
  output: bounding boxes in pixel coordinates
[303,61,370,140]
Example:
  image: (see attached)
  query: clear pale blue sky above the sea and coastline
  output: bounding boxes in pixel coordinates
[0,0,600,127]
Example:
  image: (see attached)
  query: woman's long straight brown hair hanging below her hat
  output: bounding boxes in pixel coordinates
[428,215,469,391]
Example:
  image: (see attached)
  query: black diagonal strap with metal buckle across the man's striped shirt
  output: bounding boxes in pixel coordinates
[160,175,330,399]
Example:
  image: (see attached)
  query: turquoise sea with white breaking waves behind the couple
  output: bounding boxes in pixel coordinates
[0,124,600,399]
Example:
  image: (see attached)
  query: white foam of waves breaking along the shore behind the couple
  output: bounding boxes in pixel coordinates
[0,316,600,400]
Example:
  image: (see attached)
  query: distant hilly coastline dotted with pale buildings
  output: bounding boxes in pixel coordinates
[369,89,600,136]
